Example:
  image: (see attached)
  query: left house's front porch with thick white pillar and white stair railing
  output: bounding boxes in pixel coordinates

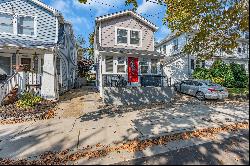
[0,47,58,104]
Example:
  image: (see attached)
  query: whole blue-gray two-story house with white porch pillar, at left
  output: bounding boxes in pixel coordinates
[0,0,76,104]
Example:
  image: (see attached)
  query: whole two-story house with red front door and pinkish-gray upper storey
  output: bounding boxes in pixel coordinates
[94,10,174,104]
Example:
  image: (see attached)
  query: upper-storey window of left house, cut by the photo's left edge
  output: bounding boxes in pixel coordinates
[0,13,13,33]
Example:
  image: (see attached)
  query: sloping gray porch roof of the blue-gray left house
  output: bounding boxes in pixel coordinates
[0,38,55,49]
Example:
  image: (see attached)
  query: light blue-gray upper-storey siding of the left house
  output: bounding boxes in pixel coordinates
[0,0,56,42]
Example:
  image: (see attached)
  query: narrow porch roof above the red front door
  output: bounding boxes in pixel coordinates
[99,47,164,58]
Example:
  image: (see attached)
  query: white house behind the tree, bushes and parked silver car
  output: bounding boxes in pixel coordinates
[155,32,249,82]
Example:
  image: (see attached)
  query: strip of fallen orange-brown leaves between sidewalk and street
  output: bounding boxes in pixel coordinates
[0,122,249,165]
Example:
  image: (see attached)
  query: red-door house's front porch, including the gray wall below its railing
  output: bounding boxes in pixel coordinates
[97,50,174,105]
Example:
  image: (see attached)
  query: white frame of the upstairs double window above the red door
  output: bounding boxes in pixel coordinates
[115,26,142,48]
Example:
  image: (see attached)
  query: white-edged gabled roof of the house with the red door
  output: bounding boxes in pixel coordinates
[96,10,158,31]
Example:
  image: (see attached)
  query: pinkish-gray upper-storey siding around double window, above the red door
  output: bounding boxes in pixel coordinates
[101,16,154,51]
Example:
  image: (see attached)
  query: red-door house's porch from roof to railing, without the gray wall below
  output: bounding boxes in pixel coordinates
[96,47,171,96]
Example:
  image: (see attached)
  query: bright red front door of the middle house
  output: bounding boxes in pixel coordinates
[128,57,138,82]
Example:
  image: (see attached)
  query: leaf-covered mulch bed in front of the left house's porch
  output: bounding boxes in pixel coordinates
[0,100,56,125]
